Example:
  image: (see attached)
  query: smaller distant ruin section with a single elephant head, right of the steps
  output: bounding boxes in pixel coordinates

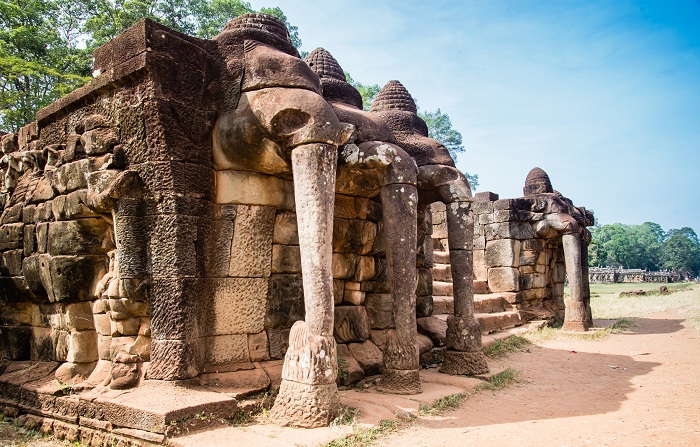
[433,168,594,331]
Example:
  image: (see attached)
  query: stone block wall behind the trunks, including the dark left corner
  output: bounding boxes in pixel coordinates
[0,20,433,388]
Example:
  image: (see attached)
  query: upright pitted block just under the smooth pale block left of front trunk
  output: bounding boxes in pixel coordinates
[229,205,275,278]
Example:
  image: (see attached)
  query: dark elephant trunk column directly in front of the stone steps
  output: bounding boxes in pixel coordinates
[440,202,489,375]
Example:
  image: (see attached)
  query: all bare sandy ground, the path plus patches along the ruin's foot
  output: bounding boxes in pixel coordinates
[0,312,700,447]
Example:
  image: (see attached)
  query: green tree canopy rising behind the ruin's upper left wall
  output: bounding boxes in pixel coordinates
[0,0,301,132]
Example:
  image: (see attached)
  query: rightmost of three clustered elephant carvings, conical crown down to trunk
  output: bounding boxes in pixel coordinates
[371,81,488,383]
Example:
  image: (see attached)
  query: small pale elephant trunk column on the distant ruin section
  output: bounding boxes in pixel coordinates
[561,231,588,331]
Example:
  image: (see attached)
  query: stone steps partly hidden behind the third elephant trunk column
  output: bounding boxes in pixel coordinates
[432,250,525,334]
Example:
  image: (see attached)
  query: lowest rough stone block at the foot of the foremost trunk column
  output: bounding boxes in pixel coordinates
[270,380,341,428]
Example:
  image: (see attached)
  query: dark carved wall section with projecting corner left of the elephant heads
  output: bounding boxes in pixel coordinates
[0,21,221,384]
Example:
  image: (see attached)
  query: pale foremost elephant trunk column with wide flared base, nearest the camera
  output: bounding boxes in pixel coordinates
[271,144,340,428]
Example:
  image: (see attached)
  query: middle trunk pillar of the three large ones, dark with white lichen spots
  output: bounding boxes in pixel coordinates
[381,184,421,394]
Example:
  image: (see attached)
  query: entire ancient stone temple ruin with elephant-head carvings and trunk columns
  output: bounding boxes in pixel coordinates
[0,14,590,445]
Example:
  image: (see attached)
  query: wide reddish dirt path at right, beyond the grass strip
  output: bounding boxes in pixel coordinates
[381,313,700,447]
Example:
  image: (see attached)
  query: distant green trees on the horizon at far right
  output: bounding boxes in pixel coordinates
[588,222,700,275]
